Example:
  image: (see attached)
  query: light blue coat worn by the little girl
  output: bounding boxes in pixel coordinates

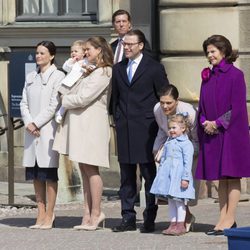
[150,134,195,201]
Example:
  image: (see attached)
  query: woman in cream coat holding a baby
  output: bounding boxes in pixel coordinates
[53,37,113,230]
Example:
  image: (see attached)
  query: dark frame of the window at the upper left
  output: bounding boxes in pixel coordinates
[16,0,98,23]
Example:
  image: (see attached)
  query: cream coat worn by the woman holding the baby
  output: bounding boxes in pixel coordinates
[53,67,112,167]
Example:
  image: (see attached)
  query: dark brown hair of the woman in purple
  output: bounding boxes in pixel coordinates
[202,35,238,63]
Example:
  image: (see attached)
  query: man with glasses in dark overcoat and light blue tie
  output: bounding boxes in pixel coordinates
[112,30,168,233]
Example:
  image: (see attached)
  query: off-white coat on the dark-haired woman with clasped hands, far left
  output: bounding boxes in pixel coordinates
[20,65,64,168]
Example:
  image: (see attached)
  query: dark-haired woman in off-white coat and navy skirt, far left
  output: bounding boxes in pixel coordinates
[20,41,64,229]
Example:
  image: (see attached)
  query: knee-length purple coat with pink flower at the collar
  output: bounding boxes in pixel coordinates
[196,60,250,180]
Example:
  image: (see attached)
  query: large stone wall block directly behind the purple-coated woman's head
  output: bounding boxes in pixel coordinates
[160,7,239,54]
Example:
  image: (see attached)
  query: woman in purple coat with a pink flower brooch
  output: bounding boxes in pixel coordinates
[196,35,250,235]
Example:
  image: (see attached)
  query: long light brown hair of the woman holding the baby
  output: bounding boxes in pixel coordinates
[86,36,113,67]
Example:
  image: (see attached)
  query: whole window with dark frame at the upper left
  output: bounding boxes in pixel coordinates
[16,0,98,22]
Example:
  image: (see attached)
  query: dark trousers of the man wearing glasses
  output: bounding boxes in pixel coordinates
[120,162,158,226]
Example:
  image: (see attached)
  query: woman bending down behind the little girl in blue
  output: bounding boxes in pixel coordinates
[153,84,198,232]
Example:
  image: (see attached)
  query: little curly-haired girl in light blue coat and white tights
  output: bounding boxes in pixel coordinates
[150,113,195,235]
